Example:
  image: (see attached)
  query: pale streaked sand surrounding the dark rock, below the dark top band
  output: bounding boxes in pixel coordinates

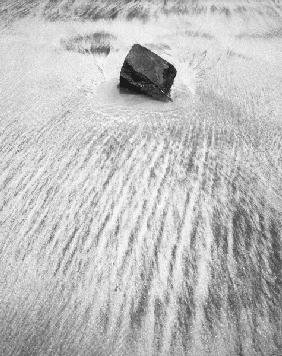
[0,4,282,356]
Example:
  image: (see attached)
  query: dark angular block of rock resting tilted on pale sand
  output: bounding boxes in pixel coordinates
[120,44,176,101]
